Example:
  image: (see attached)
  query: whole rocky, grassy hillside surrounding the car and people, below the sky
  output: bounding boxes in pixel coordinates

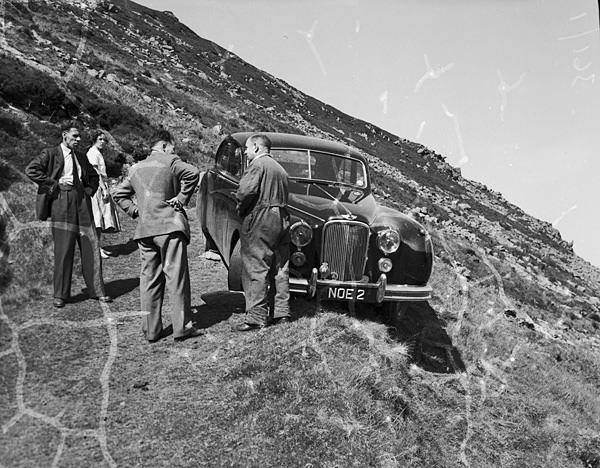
[0,0,600,467]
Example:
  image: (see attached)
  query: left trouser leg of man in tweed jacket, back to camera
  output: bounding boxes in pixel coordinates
[138,238,165,340]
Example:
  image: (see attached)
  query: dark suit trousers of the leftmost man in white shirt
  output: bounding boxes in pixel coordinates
[51,189,105,300]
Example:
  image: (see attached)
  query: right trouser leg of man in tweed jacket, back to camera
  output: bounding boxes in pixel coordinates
[154,232,192,338]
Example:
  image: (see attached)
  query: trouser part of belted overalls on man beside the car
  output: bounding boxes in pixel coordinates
[241,207,290,325]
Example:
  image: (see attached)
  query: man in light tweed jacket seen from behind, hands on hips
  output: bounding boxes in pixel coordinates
[113,130,202,342]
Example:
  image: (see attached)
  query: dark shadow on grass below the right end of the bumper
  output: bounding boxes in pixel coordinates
[389,302,466,374]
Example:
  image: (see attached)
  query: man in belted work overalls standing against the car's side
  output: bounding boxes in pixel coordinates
[235,134,290,331]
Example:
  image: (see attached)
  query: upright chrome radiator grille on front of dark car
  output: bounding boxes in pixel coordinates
[321,221,369,281]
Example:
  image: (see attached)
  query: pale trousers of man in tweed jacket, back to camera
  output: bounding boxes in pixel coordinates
[138,232,192,340]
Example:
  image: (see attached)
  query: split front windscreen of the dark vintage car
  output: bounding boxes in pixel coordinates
[271,149,367,188]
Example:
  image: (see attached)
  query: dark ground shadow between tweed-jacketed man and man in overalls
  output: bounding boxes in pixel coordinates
[192,291,245,328]
